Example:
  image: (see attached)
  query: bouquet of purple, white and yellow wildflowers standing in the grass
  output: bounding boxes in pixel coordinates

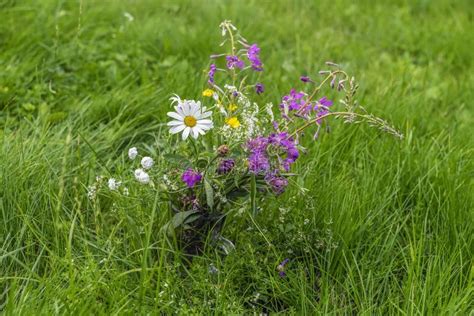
[89,21,402,254]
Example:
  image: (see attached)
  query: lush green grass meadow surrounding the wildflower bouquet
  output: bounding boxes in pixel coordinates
[0,0,474,315]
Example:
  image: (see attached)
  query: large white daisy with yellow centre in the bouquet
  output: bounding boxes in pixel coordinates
[167,96,213,140]
